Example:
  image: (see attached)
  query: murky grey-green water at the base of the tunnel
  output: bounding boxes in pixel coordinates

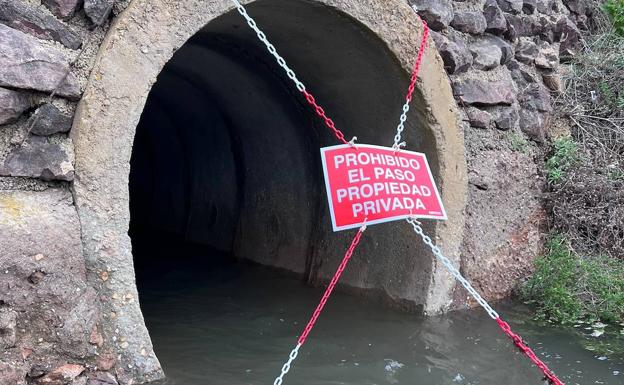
[141,265,624,385]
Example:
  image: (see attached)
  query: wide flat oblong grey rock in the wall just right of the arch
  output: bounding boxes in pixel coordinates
[453,79,516,106]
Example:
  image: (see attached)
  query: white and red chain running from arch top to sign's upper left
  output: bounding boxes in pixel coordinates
[232,0,350,144]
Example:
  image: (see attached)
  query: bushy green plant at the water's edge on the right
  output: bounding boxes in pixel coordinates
[521,235,624,324]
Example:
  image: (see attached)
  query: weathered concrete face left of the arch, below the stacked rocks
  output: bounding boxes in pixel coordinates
[0,189,99,384]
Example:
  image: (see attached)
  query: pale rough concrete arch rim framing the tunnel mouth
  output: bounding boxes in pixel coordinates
[72,0,467,382]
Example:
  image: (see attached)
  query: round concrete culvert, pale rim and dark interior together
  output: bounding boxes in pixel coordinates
[73,0,466,380]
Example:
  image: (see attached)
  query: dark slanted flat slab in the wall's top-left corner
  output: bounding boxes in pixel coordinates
[0,0,82,49]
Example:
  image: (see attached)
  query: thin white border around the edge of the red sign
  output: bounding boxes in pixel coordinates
[321,143,448,232]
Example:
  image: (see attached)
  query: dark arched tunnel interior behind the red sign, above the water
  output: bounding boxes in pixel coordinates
[129,0,437,378]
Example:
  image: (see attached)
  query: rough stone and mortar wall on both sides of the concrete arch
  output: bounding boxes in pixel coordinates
[0,0,587,384]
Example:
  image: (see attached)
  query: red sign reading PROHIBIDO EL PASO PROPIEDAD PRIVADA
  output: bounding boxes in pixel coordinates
[321,144,446,231]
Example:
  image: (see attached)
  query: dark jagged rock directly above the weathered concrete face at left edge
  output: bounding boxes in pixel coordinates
[0,137,74,181]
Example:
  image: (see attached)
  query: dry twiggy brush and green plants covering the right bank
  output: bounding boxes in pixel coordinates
[521,0,624,328]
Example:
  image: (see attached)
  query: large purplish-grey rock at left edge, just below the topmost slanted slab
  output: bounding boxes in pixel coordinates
[0,24,80,99]
